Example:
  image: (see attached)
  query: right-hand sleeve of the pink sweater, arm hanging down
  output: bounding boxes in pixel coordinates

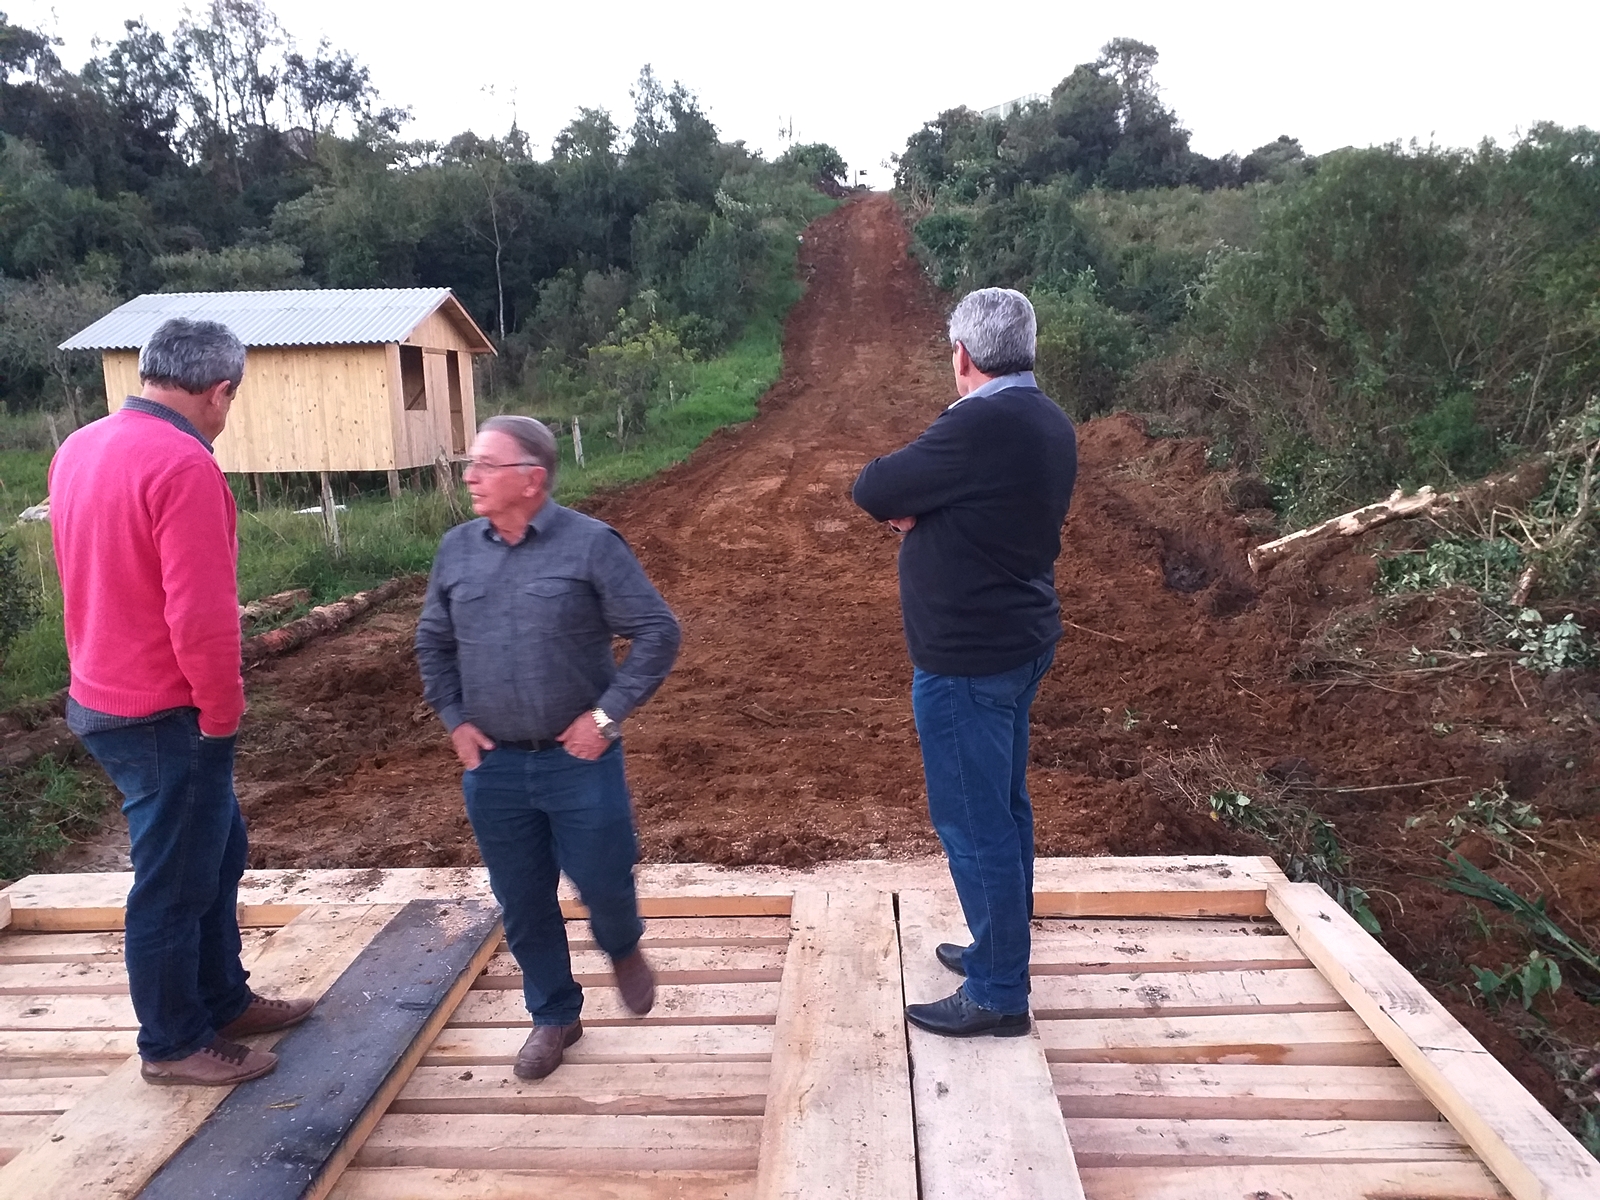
[150,461,245,738]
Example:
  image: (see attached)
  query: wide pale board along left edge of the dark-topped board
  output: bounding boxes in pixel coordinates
[0,904,398,1200]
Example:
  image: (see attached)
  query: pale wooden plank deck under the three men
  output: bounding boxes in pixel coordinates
[0,858,1580,1200]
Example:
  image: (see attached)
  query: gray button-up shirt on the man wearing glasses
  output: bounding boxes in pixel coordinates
[416,501,678,741]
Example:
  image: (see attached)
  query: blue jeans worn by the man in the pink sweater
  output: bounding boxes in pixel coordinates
[83,709,251,1062]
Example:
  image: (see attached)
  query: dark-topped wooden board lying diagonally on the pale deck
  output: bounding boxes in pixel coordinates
[139,901,501,1200]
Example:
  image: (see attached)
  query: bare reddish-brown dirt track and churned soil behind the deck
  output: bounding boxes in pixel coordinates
[37,197,1600,1132]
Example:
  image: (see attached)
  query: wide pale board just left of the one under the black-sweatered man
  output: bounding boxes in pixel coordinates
[755,890,917,1200]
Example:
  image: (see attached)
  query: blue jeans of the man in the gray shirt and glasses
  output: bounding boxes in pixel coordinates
[461,742,645,1026]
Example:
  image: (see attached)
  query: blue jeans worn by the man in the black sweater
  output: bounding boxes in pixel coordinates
[910,648,1056,1013]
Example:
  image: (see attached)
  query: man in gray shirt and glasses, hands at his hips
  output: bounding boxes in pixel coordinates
[416,416,678,1078]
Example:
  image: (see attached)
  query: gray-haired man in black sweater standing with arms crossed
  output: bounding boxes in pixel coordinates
[854,288,1078,1037]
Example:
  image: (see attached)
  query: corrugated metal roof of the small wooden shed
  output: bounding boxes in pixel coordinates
[61,288,473,350]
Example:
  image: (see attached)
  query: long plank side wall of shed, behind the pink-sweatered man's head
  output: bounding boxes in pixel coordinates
[102,346,400,472]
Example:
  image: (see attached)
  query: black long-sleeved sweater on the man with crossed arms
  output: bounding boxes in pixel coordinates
[854,387,1078,675]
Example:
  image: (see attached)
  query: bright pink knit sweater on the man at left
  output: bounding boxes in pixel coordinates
[50,411,245,736]
